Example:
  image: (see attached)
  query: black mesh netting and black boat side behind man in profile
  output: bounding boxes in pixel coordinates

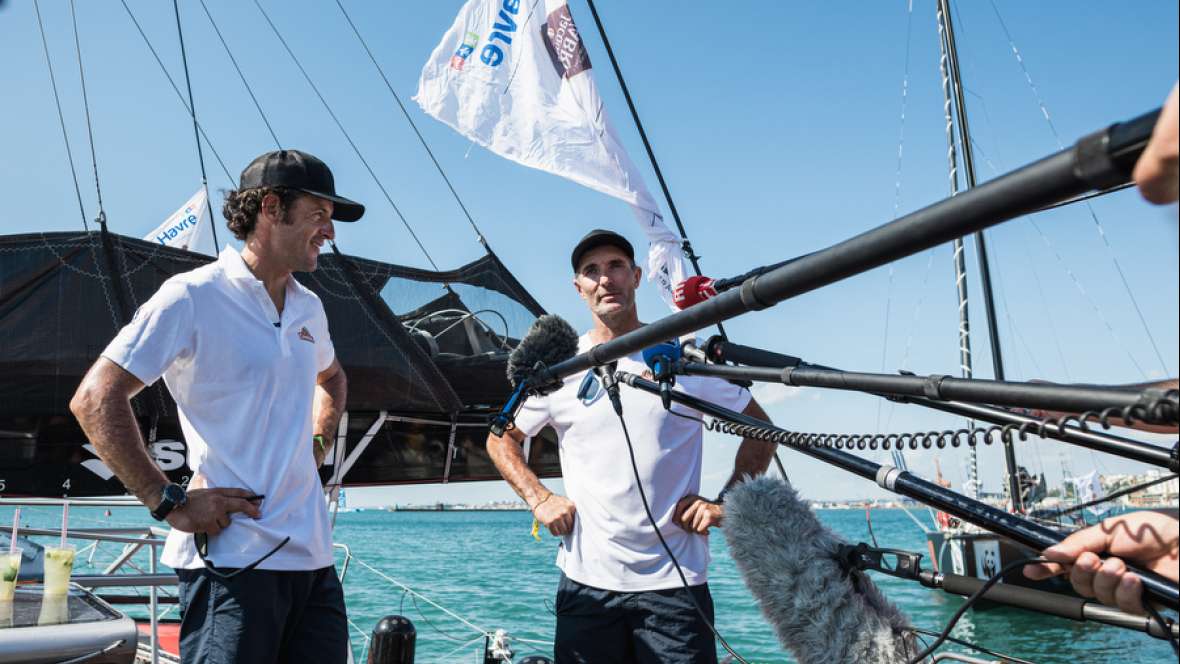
[0,232,557,495]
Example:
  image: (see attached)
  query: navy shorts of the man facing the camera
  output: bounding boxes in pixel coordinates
[553,574,717,664]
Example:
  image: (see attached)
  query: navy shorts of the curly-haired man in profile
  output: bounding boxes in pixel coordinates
[176,567,348,664]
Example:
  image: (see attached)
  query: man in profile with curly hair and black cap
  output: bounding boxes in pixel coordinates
[70,150,365,663]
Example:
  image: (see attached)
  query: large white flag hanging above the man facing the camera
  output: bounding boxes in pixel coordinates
[414,0,684,309]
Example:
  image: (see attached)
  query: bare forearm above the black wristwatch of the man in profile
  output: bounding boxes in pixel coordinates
[71,392,169,508]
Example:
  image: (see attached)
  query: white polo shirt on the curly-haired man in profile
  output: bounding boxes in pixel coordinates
[103,248,335,570]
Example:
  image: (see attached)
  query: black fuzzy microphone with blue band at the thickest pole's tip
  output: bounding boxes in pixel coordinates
[491,314,578,436]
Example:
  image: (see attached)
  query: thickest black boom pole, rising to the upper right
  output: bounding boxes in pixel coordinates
[549,110,1159,377]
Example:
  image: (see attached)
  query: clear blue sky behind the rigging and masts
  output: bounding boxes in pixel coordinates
[0,0,1180,502]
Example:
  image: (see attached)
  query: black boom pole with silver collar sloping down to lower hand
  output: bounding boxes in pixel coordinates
[616,372,1180,609]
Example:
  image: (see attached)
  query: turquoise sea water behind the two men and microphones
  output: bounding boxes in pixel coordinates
[0,507,1175,664]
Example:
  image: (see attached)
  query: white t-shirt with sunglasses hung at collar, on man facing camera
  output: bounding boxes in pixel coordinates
[516,335,750,592]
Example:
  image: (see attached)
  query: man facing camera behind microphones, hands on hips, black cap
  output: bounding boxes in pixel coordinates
[487,230,774,664]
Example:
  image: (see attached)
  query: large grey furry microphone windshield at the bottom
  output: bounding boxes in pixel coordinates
[722,478,917,664]
